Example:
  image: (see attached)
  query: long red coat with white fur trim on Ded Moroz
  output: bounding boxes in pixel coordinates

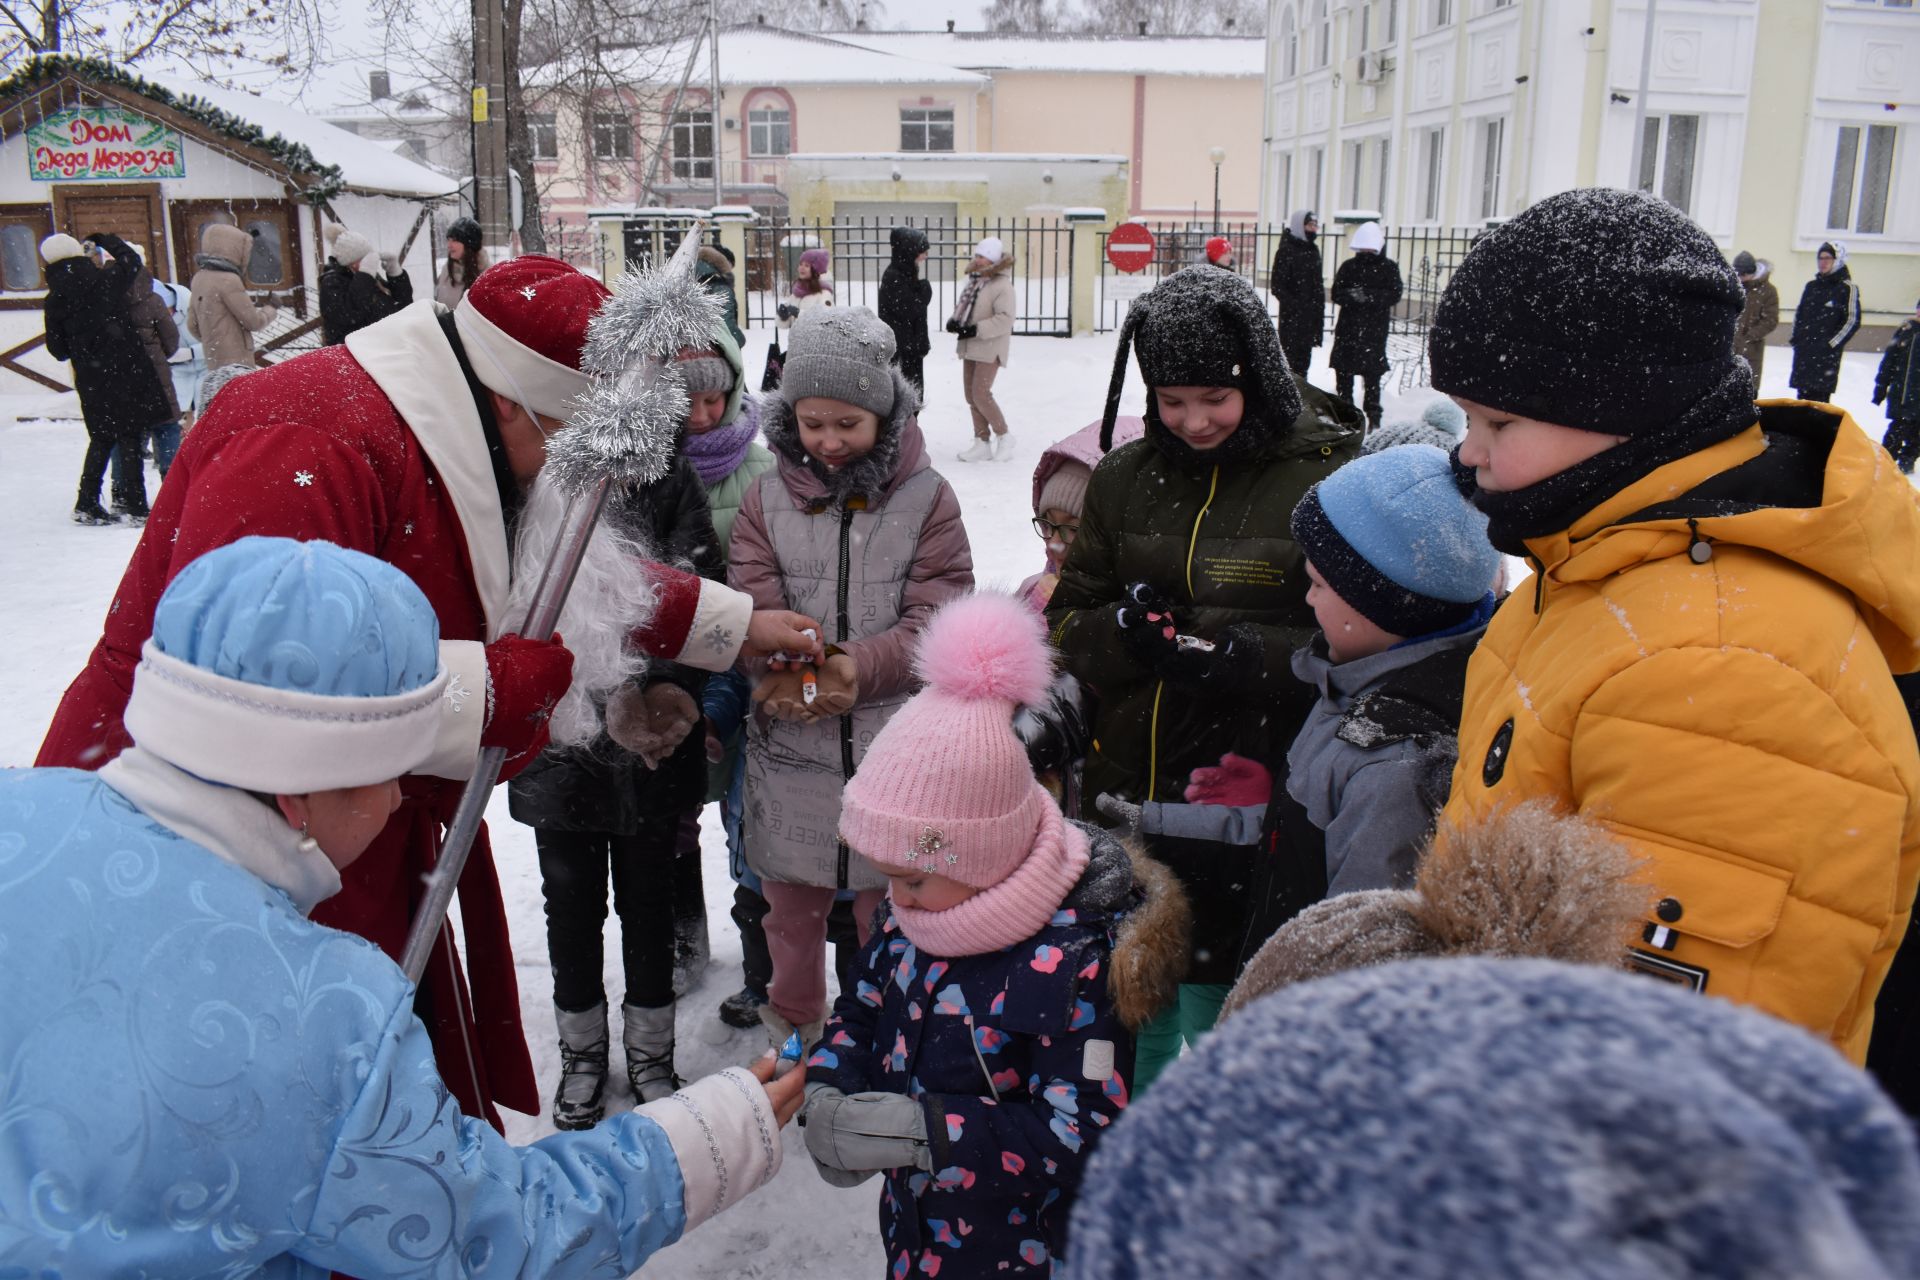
[36,301,749,1126]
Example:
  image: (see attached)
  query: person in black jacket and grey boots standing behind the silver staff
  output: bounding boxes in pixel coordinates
[507,453,726,1128]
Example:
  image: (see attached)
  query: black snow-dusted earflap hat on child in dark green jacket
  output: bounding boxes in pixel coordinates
[1100,267,1302,453]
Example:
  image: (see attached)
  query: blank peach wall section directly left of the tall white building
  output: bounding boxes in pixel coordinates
[1127,75,1263,219]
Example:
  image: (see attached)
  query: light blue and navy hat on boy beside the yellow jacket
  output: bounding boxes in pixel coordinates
[1292,445,1500,637]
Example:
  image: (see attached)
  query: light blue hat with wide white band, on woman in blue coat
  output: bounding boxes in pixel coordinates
[125,537,447,794]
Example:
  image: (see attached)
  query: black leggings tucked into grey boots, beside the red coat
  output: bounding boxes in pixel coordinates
[534,819,678,1013]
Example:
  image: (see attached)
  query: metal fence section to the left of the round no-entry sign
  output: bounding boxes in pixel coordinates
[741,219,1073,338]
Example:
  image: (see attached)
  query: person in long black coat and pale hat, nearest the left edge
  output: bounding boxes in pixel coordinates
[40,232,169,524]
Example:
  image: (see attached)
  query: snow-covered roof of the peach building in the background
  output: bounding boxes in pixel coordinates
[821,31,1267,79]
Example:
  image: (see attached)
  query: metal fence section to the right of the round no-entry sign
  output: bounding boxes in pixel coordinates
[1094,221,1482,390]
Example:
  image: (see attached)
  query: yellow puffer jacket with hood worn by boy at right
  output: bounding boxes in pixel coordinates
[1446,401,1920,1063]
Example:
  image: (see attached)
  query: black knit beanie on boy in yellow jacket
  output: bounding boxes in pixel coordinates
[1427,188,1745,436]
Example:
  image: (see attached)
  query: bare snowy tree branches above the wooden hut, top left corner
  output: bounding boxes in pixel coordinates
[0,0,328,81]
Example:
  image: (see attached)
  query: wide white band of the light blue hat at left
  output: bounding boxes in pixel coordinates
[125,639,449,794]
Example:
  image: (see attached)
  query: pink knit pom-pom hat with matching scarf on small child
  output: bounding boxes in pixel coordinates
[839,593,1087,954]
